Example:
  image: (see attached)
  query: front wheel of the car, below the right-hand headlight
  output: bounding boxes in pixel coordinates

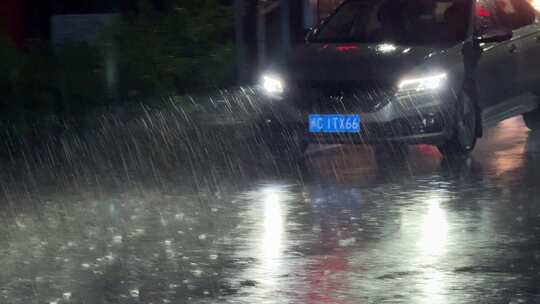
[437,91,479,158]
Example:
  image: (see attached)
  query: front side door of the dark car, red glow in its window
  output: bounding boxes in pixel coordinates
[476,0,537,123]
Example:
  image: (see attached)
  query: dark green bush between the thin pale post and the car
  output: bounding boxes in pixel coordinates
[106,0,234,95]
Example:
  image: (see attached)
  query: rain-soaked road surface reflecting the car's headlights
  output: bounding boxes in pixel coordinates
[0,119,540,304]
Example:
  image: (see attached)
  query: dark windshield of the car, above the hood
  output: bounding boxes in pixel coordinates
[313,0,471,45]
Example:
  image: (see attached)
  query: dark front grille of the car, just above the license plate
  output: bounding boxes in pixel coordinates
[293,81,395,113]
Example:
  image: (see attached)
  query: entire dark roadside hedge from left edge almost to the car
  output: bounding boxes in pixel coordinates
[0,0,234,126]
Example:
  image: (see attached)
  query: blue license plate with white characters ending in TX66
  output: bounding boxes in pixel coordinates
[309,114,360,133]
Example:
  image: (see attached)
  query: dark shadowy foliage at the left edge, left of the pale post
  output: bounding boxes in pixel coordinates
[0,39,104,125]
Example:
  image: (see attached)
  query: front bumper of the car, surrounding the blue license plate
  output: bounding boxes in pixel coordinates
[261,91,457,144]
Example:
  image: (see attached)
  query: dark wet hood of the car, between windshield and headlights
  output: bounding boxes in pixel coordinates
[283,43,461,81]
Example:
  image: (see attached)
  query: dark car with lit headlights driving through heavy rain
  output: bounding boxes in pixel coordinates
[258,0,540,157]
